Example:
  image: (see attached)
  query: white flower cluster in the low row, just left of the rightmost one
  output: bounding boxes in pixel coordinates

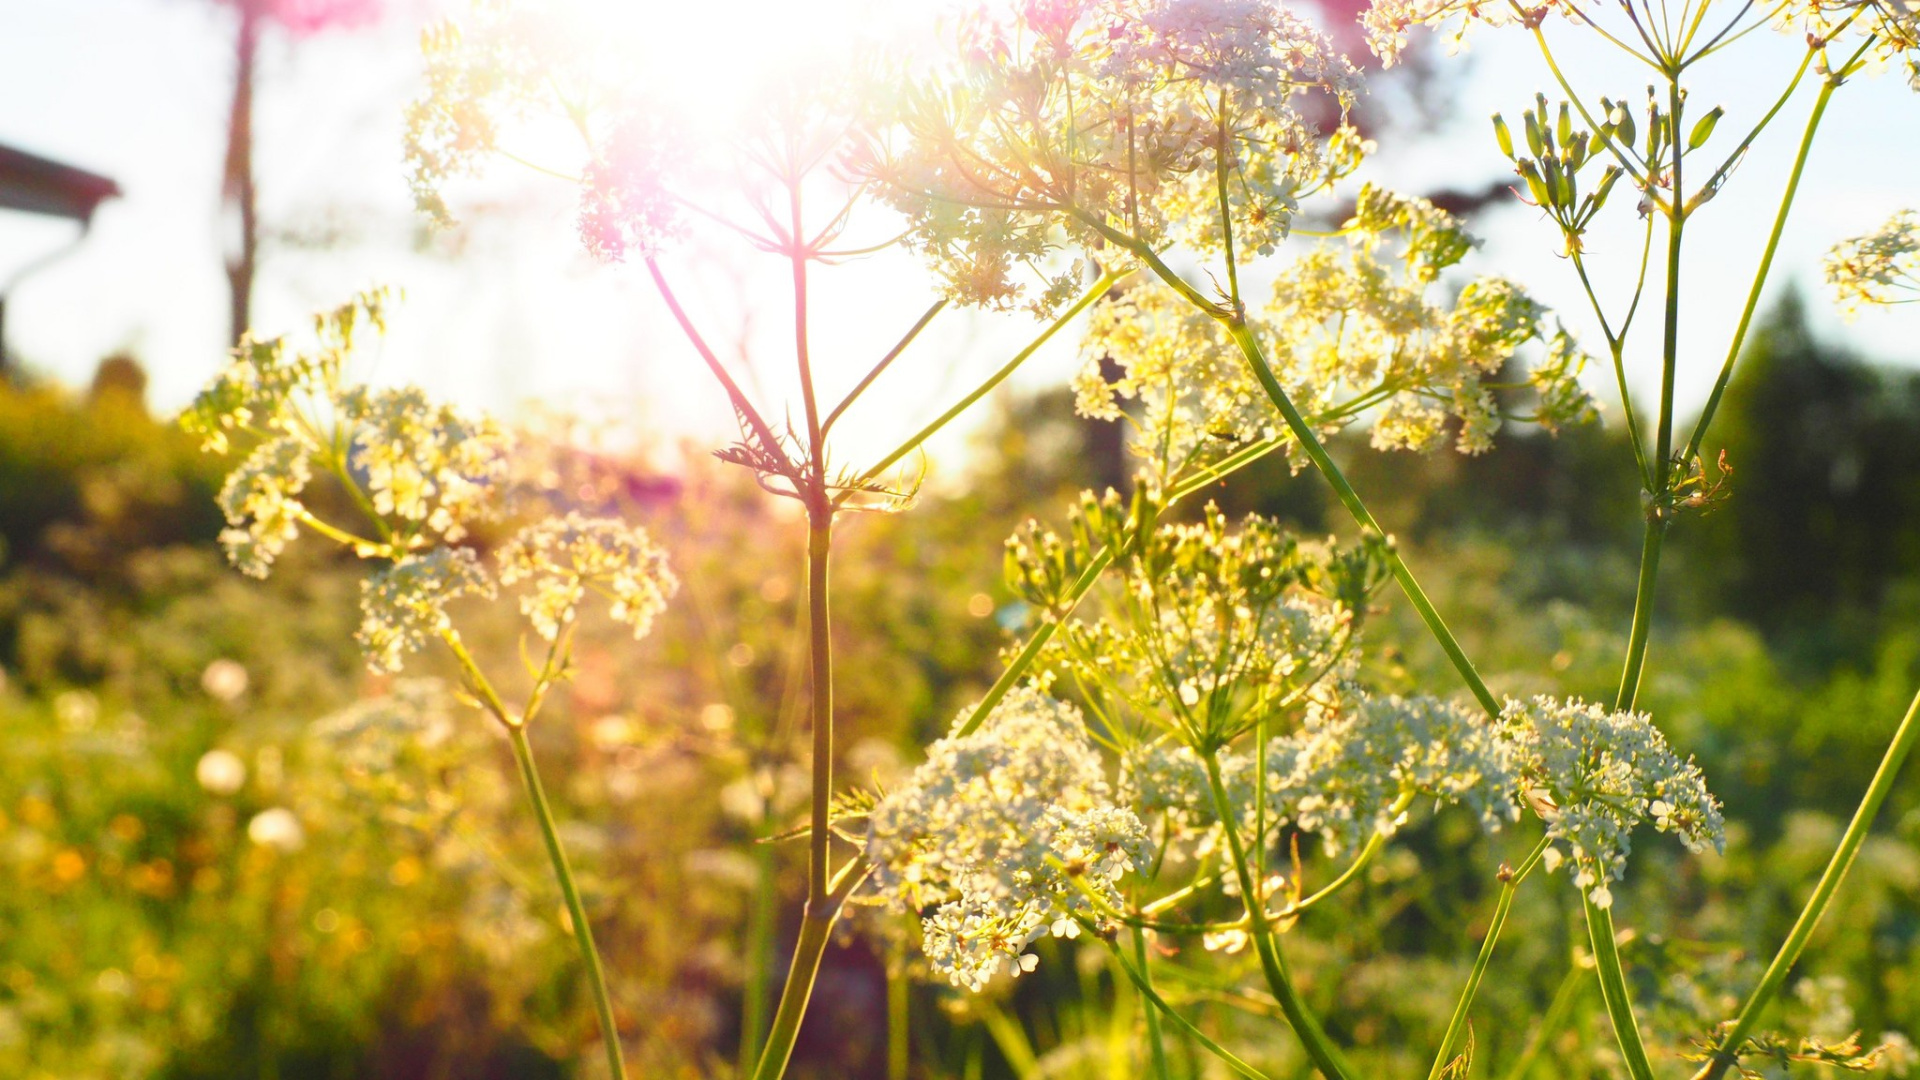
[1267,694,1521,855]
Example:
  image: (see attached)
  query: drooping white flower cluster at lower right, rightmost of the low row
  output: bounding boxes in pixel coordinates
[1501,698,1726,907]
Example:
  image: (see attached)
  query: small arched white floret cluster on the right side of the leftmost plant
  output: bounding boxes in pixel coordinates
[499,513,680,642]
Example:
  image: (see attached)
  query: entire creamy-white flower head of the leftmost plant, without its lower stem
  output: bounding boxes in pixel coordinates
[182,292,678,671]
